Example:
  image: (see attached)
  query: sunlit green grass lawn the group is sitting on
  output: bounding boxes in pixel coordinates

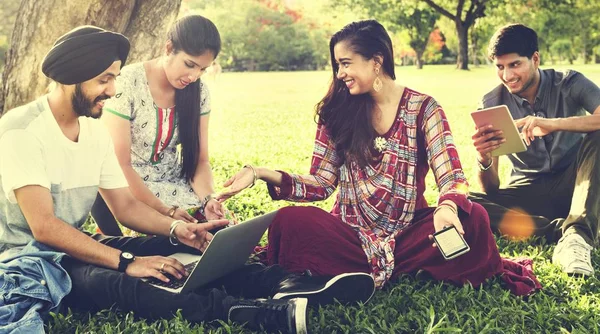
[48,65,600,333]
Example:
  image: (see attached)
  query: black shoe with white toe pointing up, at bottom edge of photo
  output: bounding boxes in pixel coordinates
[227,298,307,334]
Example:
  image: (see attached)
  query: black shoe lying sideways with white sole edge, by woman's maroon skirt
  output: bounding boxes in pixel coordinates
[273,273,375,306]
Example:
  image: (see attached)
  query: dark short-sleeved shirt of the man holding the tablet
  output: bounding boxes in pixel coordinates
[482,69,600,183]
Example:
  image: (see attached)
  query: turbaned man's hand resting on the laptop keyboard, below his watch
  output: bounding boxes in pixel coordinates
[125,256,188,282]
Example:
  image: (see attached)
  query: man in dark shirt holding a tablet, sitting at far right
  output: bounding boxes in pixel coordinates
[471,24,600,275]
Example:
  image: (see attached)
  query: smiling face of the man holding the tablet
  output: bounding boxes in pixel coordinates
[494,51,540,97]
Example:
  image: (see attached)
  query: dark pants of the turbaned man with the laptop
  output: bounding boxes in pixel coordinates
[62,235,288,322]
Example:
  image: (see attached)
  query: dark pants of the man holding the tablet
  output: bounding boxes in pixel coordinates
[469,131,600,245]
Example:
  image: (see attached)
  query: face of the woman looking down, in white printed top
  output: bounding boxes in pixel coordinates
[163,42,215,89]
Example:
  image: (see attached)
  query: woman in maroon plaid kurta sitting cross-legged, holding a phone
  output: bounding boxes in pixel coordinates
[218,20,539,294]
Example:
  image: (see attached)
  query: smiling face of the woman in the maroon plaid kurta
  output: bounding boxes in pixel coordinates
[333,41,381,95]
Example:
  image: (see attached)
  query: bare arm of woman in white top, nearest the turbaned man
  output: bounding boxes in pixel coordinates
[102,112,170,215]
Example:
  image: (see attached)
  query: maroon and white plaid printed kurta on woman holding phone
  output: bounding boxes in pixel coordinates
[269,88,472,286]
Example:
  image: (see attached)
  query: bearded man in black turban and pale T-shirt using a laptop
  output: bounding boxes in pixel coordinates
[0,26,375,333]
